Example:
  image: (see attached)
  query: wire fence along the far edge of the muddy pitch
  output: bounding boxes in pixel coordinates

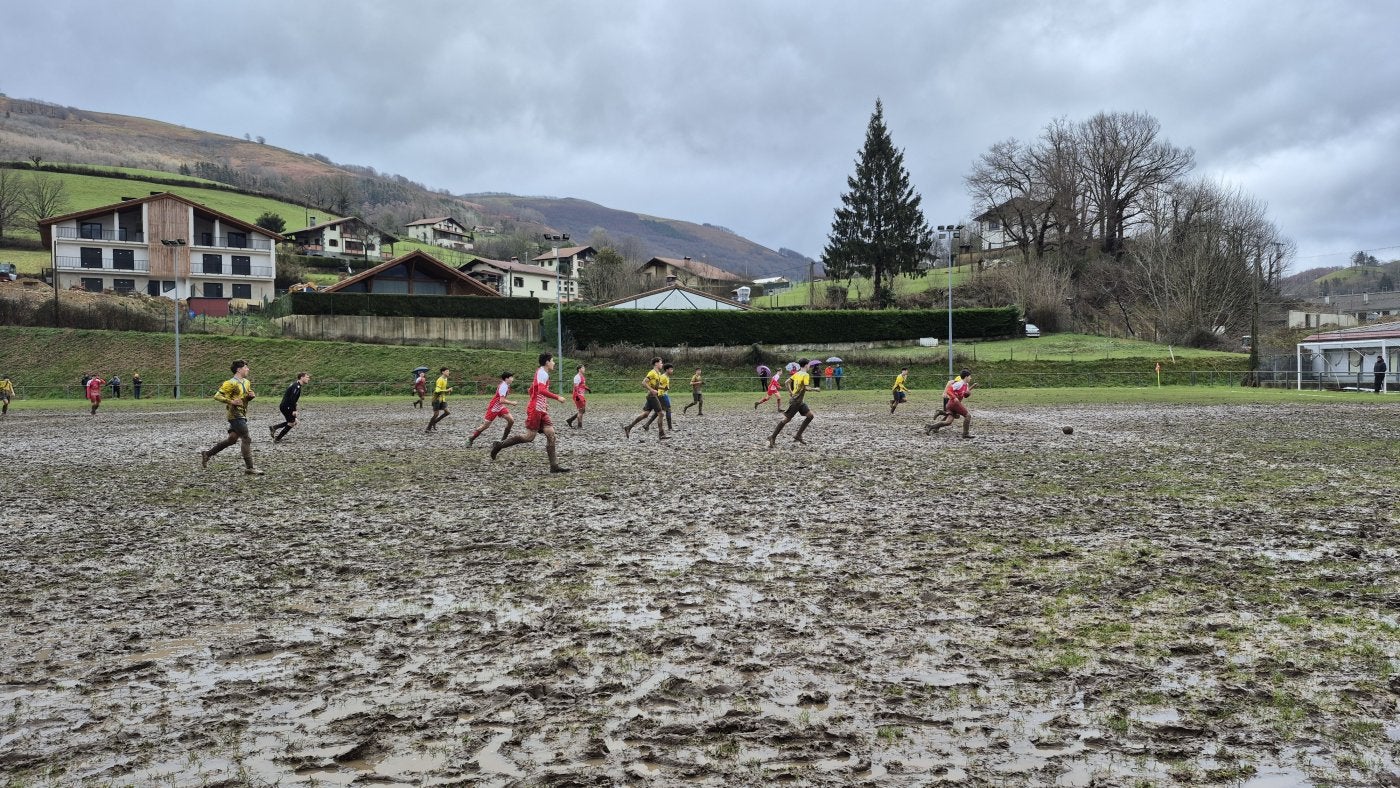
[14,370,1400,400]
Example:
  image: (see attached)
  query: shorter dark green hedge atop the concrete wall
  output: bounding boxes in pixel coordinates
[287,293,539,321]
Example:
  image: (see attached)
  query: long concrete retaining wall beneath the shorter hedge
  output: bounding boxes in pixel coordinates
[276,315,540,346]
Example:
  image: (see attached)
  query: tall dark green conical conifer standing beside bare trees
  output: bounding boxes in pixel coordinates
[822,101,934,307]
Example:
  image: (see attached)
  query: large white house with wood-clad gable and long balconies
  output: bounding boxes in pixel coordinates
[39,192,283,307]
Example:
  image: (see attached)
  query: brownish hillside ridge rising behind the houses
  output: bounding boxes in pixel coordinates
[0,97,808,279]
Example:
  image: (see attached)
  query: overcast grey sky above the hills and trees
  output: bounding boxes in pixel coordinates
[0,0,1400,270]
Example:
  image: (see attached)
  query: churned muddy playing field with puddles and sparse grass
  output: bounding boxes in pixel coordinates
[0,392,1400,787]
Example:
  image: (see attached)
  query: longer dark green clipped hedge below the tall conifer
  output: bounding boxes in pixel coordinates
[540,307,1019,349]
